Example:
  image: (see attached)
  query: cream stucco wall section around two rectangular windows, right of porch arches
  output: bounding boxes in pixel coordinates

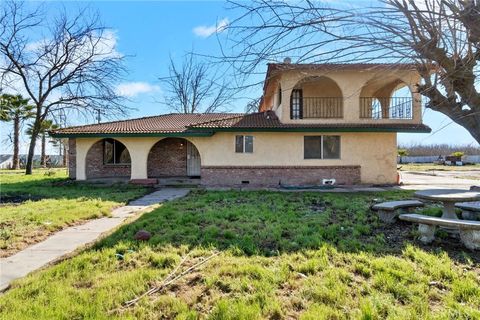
[190,132,397,184]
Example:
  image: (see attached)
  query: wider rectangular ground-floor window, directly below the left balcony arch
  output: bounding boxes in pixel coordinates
[303,136,340,159]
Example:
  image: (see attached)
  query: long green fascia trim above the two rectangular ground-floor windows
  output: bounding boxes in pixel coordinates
[191,127,432,133]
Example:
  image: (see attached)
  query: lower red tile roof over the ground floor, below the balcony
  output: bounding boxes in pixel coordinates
[52,111,430,136]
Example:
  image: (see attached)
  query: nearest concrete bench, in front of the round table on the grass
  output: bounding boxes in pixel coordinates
[399,214,480,250]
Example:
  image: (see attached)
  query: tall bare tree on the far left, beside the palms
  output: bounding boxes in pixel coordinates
[0,1,127,174]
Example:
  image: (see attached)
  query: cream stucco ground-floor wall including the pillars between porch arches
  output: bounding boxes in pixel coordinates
[76,132,397,184]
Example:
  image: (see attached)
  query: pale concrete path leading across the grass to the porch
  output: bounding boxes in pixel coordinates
[0,188,190,292]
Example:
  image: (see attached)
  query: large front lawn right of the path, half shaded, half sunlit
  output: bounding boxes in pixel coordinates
[0,191,480,319]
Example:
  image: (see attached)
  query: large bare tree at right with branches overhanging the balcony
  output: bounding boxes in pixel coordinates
[222,0,480,143]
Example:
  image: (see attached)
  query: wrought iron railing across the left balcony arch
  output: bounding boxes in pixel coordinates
[301,97,343,119]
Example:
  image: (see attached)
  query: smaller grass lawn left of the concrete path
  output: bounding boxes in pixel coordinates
[0,170,147,257]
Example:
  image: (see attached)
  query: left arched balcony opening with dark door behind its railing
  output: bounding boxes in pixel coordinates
[290,76,343,119]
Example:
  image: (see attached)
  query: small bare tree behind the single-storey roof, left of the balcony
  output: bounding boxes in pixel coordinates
[159,54,233,113]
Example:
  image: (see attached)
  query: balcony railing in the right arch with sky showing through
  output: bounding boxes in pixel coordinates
[360,97,413,120]
